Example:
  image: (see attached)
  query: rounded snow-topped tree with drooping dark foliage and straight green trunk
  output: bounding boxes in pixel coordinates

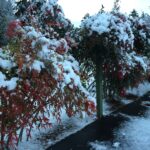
[75,7,147,117]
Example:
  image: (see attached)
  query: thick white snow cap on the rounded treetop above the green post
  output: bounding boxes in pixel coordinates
[81,12,134,50]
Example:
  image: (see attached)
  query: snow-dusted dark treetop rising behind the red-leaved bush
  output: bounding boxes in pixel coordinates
[16,0,72,38]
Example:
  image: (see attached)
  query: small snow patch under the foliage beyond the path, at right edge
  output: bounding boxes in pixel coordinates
[127,81,150,96]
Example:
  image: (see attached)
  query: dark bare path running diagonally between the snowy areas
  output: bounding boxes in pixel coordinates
[47,94,150,150]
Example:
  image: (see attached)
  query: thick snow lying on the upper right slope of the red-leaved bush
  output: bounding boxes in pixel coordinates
[24,26,85,92]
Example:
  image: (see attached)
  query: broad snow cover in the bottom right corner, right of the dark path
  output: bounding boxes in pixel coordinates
[89,110,150,150]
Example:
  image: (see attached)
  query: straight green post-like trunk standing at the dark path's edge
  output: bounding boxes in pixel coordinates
[95,63,103,118]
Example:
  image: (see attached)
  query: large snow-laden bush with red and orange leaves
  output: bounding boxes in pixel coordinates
[0,0,95,149]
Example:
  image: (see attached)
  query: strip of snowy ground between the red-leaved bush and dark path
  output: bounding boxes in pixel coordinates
[18,111,95,150]
